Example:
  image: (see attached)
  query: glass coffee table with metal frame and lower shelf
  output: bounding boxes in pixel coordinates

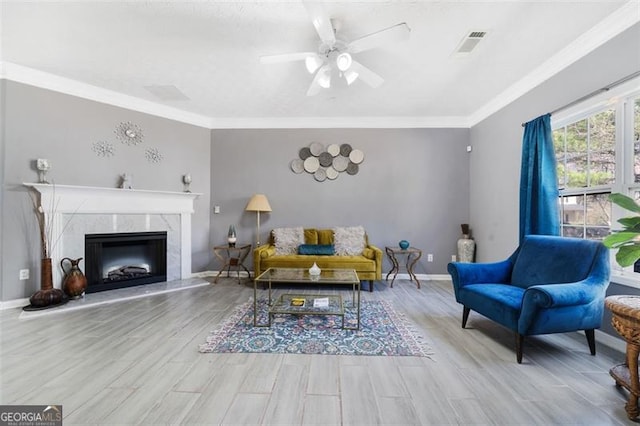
[253,268,360,330]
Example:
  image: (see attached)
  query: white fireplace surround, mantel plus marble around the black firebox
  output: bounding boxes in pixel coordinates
[24,183,201,287]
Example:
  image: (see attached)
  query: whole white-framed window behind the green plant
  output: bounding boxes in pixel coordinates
[552,83,640,283]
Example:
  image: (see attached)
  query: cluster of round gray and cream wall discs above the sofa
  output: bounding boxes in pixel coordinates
[289,142,364,182]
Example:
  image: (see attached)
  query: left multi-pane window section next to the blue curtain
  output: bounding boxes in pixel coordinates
[553,108,616,240]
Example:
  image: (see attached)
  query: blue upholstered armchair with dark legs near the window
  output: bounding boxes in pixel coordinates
[448,235,610,364]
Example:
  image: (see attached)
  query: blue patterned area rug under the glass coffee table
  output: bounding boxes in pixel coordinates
[200,301,432,357]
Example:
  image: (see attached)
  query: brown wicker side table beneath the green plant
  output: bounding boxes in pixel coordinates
[604,295,640,420]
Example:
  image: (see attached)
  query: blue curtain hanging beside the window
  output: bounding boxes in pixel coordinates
[520,114,560,242]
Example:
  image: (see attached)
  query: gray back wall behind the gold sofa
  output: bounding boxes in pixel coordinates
[211,129,469,274]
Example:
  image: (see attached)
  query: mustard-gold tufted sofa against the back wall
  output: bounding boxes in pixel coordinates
[253,228,382,291]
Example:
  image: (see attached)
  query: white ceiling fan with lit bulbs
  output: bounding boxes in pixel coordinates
[260,0,411,96]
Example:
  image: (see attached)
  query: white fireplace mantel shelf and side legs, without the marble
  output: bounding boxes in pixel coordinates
[23,183,201,287]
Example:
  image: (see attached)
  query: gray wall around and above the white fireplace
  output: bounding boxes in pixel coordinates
[0,81,211,300]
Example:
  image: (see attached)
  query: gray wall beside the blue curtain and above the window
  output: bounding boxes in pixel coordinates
[470,25,640,262]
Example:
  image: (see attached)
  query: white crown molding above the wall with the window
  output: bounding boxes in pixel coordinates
[468,0,640,126]
